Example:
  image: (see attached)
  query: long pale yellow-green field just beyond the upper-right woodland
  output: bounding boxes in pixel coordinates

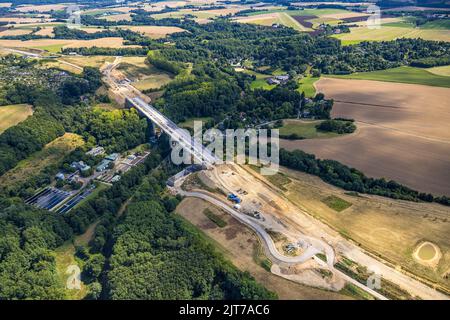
[334,25,450,44]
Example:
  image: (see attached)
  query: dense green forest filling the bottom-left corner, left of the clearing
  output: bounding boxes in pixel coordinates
[0,197,73,299]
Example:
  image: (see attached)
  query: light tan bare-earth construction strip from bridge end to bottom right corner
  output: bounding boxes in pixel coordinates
[199,165,448,300]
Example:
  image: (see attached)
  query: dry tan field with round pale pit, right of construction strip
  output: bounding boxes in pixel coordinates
[278,167,450,290]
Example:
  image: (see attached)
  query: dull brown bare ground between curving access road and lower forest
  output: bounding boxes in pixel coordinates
[177,198,349,300]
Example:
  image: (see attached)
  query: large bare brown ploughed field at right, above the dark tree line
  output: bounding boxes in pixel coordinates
[281,79,450,195]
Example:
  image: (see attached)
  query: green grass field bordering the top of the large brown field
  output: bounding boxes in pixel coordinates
[327,67,450,88]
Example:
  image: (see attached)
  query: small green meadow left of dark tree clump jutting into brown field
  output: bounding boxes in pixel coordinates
[279,120,339,139]
